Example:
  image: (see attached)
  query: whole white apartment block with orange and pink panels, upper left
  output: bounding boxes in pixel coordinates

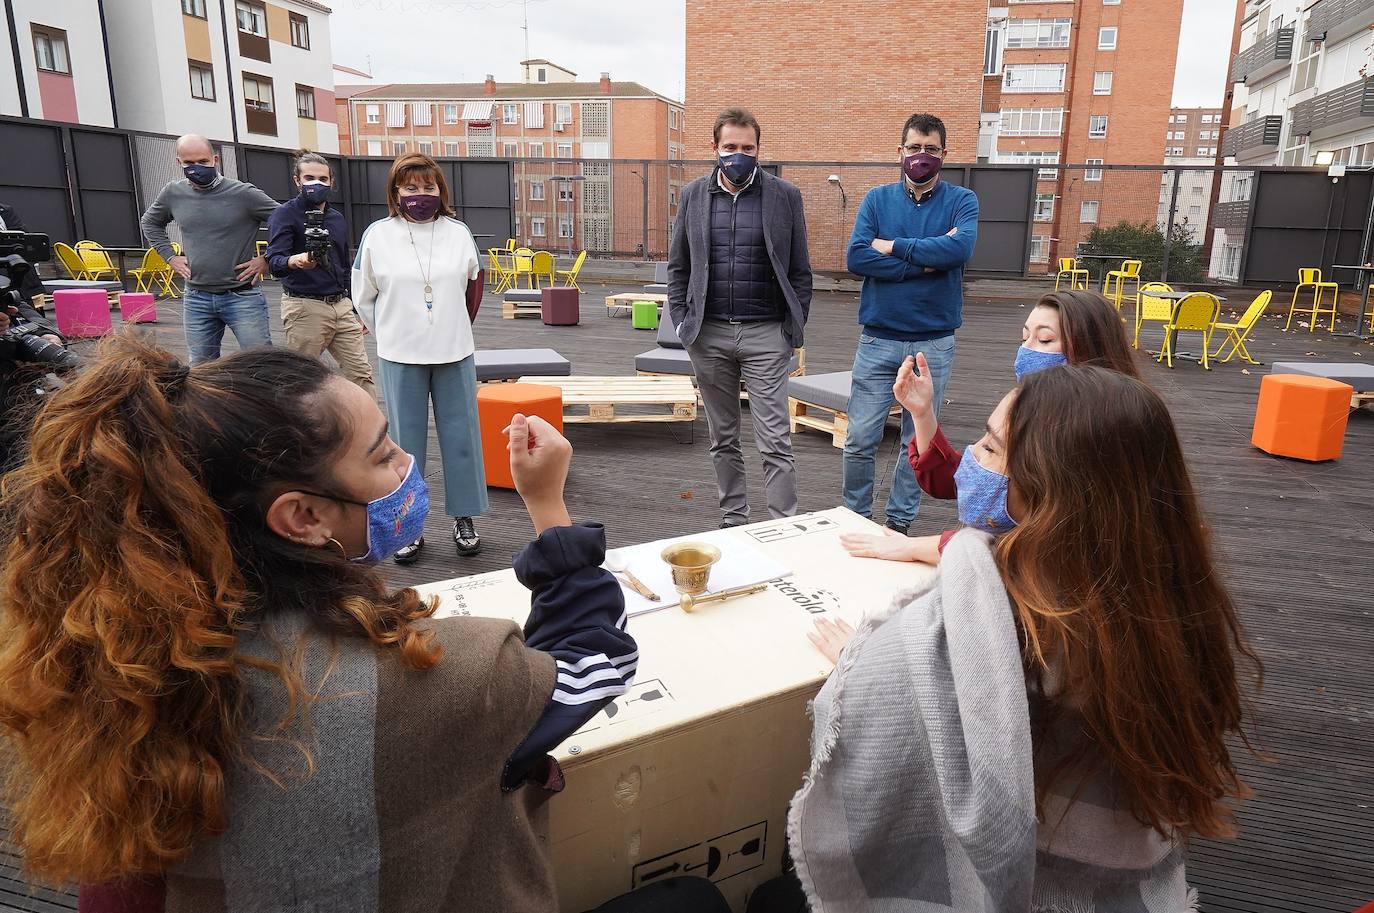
[0,0,339,153]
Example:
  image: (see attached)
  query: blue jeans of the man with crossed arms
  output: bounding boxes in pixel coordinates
[844,333,954,527]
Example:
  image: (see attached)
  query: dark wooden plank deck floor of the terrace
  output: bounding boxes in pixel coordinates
[0,285,1374,913]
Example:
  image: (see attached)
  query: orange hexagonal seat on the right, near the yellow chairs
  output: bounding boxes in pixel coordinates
[1250,374,1355,462]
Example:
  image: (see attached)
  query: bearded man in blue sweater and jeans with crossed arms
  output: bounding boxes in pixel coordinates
[844,114,978,535]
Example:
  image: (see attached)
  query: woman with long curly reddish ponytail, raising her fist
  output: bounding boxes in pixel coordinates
[0,338,638,913]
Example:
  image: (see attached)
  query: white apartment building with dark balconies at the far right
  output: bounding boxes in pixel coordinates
[1210,0,1374,279]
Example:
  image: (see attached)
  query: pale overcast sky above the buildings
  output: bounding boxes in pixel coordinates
[328,0,1235,107]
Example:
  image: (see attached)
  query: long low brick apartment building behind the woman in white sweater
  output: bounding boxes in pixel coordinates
[337,59,684,252]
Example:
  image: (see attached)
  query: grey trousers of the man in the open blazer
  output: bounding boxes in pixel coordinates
[687,320,797,525]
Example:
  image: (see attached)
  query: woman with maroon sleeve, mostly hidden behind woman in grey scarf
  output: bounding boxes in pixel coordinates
[841,290,1140,564]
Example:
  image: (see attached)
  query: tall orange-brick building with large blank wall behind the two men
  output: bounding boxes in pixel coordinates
[687,0,1183,270]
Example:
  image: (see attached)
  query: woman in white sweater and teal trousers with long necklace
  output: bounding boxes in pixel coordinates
[353,153,486,564]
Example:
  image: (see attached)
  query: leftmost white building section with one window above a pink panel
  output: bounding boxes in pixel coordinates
[0,0,115,127]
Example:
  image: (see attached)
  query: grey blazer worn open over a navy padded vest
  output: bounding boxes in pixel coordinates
[668,169,811,348]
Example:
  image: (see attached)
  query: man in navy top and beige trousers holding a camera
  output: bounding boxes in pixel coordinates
[265,153,376,397]
